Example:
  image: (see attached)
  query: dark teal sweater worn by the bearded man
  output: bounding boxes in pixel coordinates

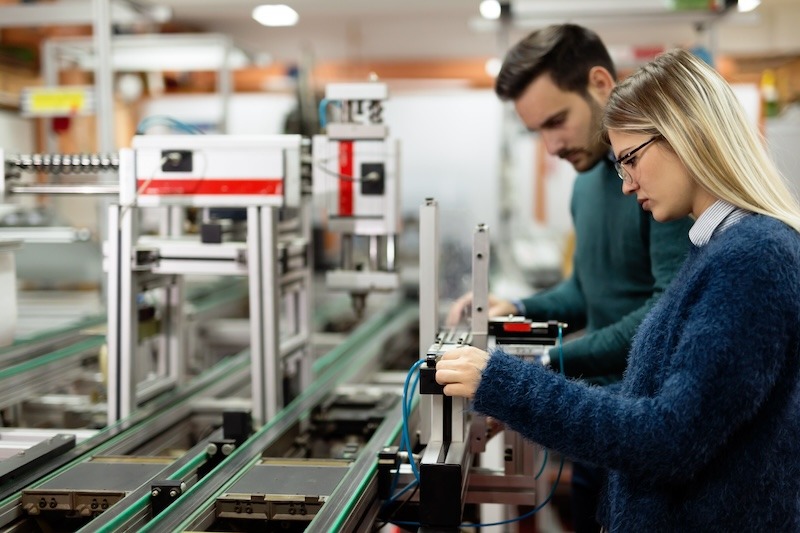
[522,158,692,384]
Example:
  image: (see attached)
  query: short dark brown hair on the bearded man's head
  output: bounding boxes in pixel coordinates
[494,24,617,100]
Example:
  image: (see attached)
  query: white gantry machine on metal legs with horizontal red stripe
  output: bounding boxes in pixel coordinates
[106,135,312,424]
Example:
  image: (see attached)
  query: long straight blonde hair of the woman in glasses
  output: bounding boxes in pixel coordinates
[603,50,800,231]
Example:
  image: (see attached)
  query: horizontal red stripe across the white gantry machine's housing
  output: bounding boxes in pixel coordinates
[136,178,283,196]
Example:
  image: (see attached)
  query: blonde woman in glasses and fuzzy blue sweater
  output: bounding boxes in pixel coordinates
[436,50,800,531]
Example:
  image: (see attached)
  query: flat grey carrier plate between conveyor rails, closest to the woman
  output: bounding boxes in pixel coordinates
[216,459,350,521]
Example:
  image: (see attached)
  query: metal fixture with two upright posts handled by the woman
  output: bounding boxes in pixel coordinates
[378,199,566,532]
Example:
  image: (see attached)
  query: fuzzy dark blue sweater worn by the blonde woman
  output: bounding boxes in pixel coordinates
[474,215,800,532]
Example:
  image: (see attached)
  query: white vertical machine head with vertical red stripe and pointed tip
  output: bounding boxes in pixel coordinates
[313,81,400,318]
